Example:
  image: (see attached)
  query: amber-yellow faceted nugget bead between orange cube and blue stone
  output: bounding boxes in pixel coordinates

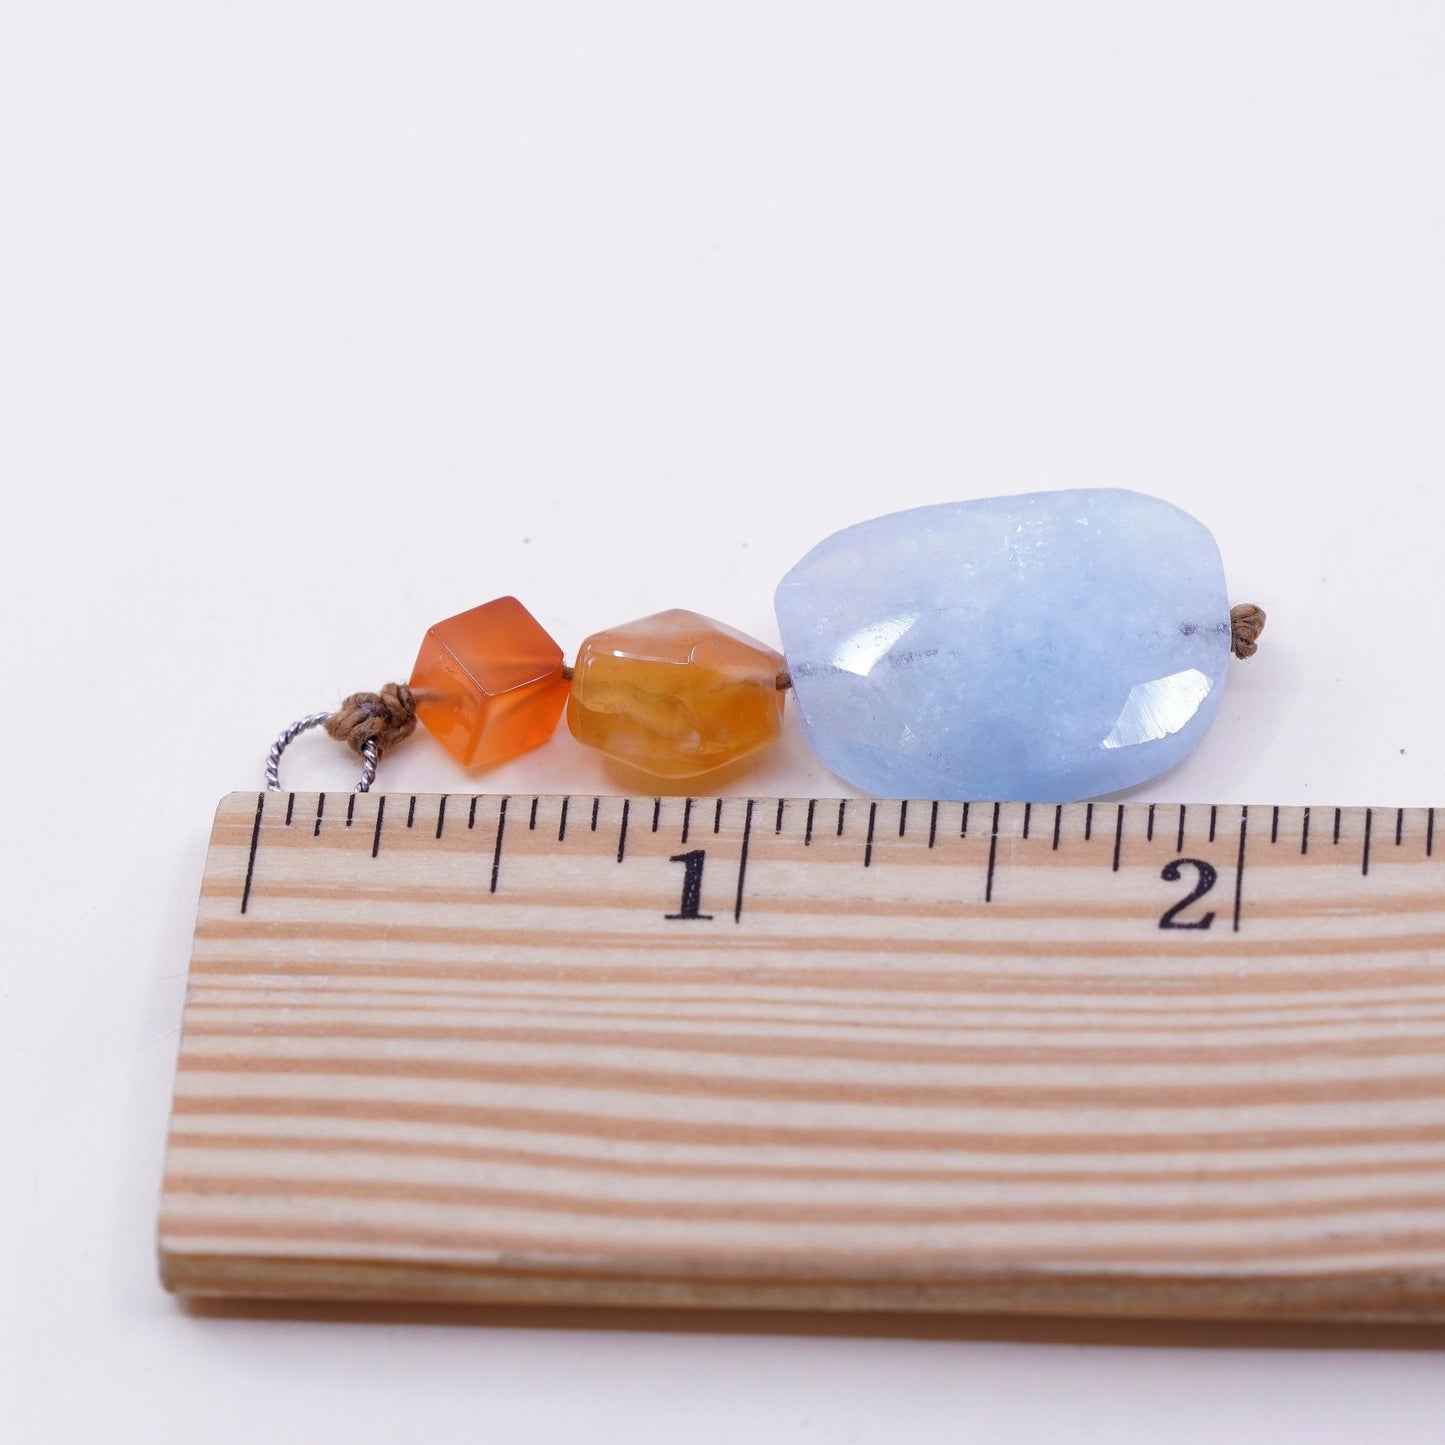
[566,608,783,777]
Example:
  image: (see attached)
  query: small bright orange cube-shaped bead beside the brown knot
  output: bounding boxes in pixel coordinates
[412,597,568,767]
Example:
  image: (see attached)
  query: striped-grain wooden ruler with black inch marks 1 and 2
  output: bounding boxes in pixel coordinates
[160,793,1445,1319]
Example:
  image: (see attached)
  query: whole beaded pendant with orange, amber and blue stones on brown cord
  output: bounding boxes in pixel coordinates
[267,488,1264,802]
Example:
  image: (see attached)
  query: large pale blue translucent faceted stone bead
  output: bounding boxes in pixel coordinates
[776,490,1231,802]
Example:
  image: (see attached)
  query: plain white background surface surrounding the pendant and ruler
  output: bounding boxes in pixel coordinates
[0,0,1445,1445]
